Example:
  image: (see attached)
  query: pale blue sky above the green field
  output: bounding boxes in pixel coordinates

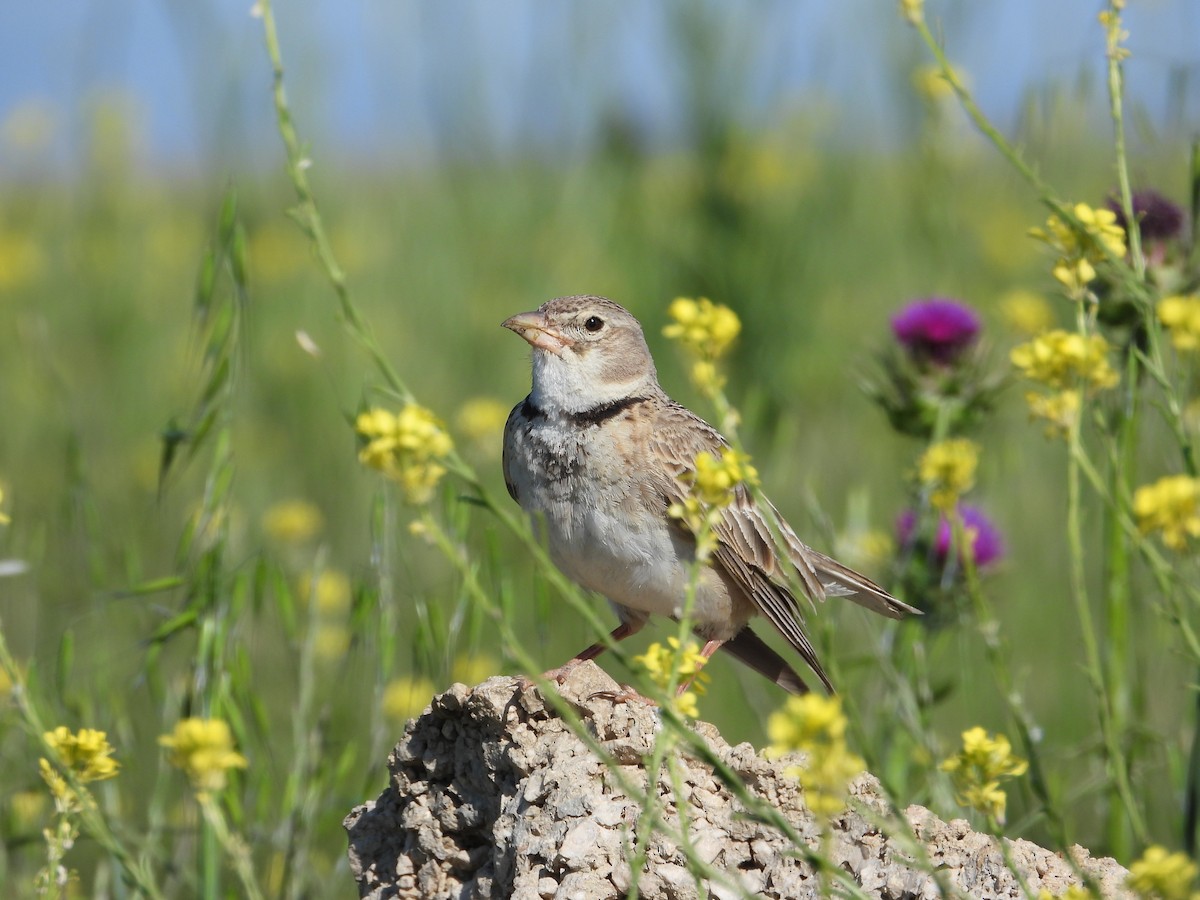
[0,0,1200,166]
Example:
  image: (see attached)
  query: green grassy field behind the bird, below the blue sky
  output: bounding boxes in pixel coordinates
[0,5,1198,896]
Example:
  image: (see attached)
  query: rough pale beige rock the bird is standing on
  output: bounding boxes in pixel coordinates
[346,664,1127,900]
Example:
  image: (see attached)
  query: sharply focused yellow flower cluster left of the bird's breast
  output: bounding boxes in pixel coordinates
[354,403,454,504]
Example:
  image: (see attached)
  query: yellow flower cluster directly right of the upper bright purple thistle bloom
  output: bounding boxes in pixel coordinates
[1009,329,1121,436]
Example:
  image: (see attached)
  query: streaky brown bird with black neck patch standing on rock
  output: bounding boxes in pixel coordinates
[503,294,919,695]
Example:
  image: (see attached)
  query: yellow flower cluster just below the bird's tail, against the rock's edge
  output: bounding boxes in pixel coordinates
[767,694,866,816]
